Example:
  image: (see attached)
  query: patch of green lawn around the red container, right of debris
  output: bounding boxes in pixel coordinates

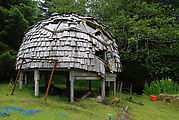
[117,94,179,120]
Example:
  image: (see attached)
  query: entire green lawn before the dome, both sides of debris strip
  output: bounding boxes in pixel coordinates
[0,84,179,120]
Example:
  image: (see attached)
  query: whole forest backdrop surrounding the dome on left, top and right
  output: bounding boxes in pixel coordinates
[0,0,179,93]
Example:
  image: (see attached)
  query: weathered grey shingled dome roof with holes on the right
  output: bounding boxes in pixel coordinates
[16,13,121,74]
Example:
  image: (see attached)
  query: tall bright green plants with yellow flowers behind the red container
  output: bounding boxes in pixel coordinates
[144,78,179,95]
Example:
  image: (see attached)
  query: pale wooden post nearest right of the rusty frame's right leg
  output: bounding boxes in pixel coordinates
[69,71,74,102]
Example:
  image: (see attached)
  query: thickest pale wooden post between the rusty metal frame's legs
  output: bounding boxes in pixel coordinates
[34,70,40,97]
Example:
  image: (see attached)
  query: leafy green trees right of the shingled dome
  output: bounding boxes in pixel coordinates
[89,0,179,81]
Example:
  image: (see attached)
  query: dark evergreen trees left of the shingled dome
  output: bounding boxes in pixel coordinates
[0,0,41,80]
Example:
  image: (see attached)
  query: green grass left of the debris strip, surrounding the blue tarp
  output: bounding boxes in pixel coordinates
[0,84,116,120]
